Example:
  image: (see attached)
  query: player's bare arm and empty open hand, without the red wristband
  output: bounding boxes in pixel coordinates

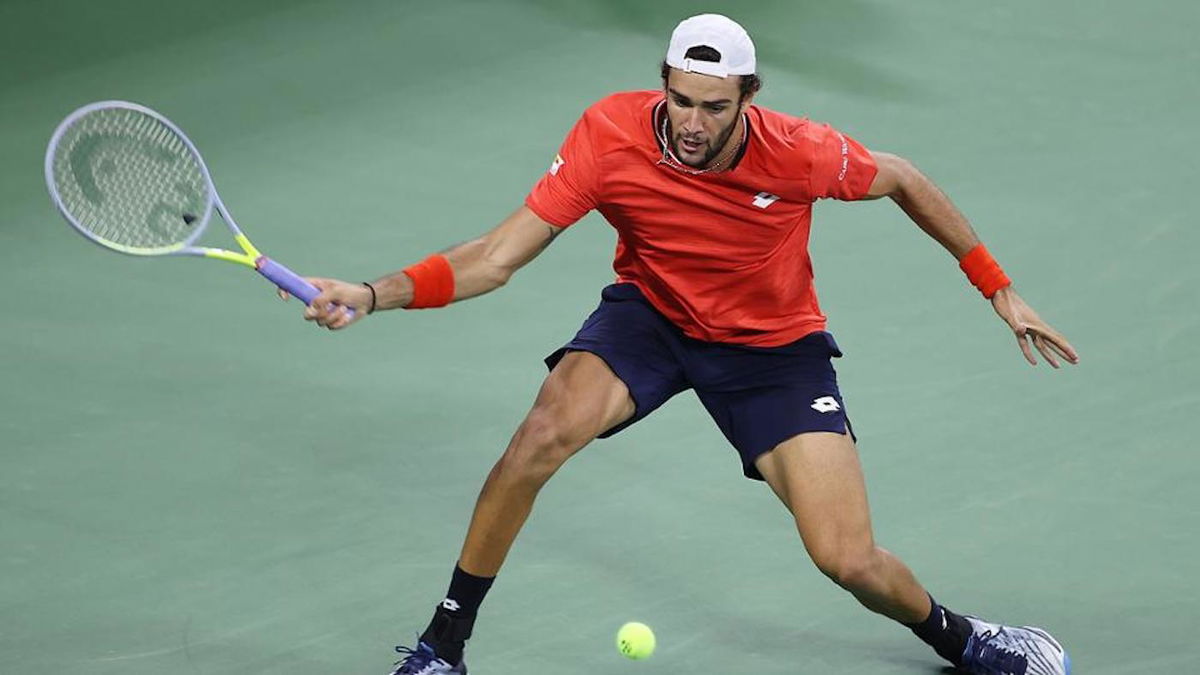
[866,151,1079,368]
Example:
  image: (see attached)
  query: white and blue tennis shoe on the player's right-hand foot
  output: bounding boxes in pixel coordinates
[961,616,1070,675]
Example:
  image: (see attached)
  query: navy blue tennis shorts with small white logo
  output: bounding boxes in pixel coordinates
[546,283,853,480]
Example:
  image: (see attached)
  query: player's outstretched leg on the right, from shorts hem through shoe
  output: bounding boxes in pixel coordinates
[754,432,1070,675]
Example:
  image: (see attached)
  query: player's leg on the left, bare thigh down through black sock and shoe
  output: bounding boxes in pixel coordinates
[394,351,635,675]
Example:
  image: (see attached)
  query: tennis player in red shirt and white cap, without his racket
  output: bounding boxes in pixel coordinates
[297,14,1078,675]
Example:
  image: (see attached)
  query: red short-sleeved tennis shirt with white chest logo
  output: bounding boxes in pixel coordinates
[526,91,876,347]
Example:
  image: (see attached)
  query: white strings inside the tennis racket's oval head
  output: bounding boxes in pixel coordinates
[53,108,211,252]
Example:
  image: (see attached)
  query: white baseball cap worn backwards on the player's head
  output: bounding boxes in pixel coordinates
[667,14,756,77]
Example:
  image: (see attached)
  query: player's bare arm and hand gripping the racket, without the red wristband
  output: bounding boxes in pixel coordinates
[305,205,563,330]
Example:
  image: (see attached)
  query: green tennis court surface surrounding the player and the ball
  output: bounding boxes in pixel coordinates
[0,0,1200,675]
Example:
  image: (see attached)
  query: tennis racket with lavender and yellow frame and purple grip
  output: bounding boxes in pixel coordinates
[46,101,343,311]
